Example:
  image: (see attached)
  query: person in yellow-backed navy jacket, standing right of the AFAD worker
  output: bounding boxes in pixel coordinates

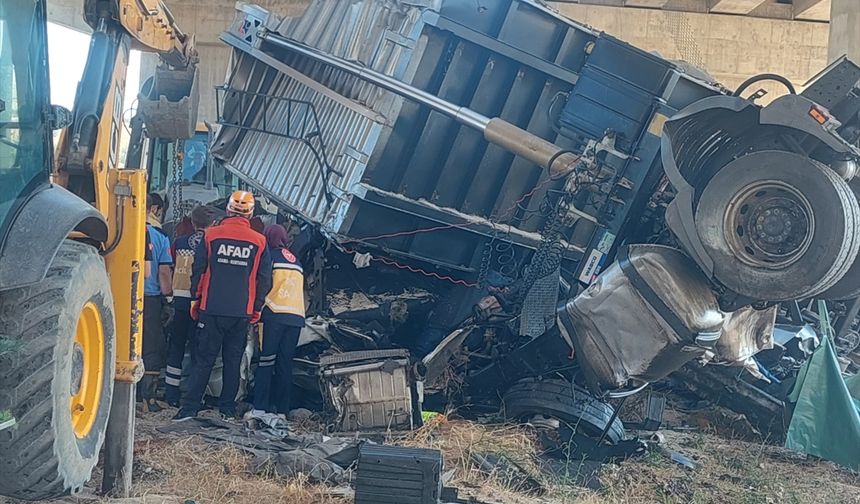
[246,224,305,418]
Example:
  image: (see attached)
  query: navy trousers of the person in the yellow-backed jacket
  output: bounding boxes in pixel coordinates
[254,317,302,414]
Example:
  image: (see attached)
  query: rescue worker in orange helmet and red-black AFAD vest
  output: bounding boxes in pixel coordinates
[173,191,272,421]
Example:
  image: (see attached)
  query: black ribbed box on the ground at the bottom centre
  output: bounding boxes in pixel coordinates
[355,443,443,504]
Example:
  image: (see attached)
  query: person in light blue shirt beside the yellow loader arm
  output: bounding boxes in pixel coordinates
[143,193,173,412]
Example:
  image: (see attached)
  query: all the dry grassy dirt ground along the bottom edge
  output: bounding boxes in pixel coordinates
[0,410,860,504]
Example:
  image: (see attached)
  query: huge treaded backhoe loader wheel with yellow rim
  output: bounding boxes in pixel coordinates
[0,240,116,500]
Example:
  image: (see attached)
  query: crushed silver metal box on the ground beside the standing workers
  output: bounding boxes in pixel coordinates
[320,349,414,431]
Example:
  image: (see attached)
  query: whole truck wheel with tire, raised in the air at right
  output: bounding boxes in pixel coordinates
[696,151,860,301]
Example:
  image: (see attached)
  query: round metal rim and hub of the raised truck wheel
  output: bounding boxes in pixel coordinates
[725,181,815,269]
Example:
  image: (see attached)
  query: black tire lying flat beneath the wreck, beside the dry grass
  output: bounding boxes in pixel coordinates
[503,379,624,445]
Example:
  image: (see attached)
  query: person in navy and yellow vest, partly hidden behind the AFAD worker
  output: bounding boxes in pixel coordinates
[164,205,215,407]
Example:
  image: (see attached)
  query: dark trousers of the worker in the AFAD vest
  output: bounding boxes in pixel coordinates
[182,313,248,415]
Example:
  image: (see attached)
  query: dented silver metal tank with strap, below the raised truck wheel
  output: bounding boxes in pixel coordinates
[560,245,724,393]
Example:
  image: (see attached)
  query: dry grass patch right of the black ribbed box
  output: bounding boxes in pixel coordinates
[399,418,860,504]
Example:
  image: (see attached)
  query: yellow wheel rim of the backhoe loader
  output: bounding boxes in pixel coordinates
[70,302,105,439]
